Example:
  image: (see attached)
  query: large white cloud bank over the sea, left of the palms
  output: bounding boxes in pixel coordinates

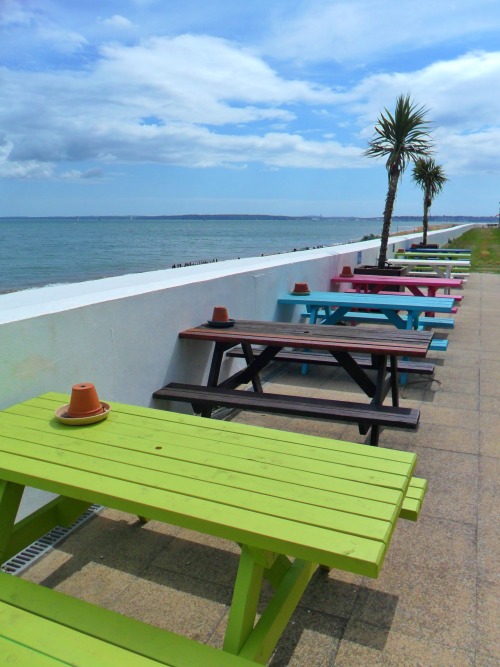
[0,35,352,177]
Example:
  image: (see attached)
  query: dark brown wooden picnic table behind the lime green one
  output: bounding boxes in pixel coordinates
[153,320,433,445]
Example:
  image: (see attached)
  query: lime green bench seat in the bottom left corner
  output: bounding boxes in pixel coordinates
[0,572,256,667]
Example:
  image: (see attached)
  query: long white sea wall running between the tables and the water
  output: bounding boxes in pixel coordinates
[0,225,473,409]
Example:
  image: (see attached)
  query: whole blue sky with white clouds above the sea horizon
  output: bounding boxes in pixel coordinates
[0,0,500,217]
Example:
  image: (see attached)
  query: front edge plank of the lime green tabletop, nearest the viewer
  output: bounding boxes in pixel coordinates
[0,446,386,576]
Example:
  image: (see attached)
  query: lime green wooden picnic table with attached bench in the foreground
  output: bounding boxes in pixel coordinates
[0,393,426,667]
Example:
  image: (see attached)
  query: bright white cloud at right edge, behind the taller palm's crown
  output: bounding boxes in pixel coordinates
[345,52,500,172]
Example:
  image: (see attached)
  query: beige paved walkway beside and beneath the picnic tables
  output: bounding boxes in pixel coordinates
[16,274,500,667]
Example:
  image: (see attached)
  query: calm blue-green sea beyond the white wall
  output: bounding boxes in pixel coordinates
[0,218,419,293]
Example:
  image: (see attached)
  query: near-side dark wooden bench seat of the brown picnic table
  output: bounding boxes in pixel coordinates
[153,382,420,445]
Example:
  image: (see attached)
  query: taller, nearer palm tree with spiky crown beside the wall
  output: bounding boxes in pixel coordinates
[365,94,432,269]
